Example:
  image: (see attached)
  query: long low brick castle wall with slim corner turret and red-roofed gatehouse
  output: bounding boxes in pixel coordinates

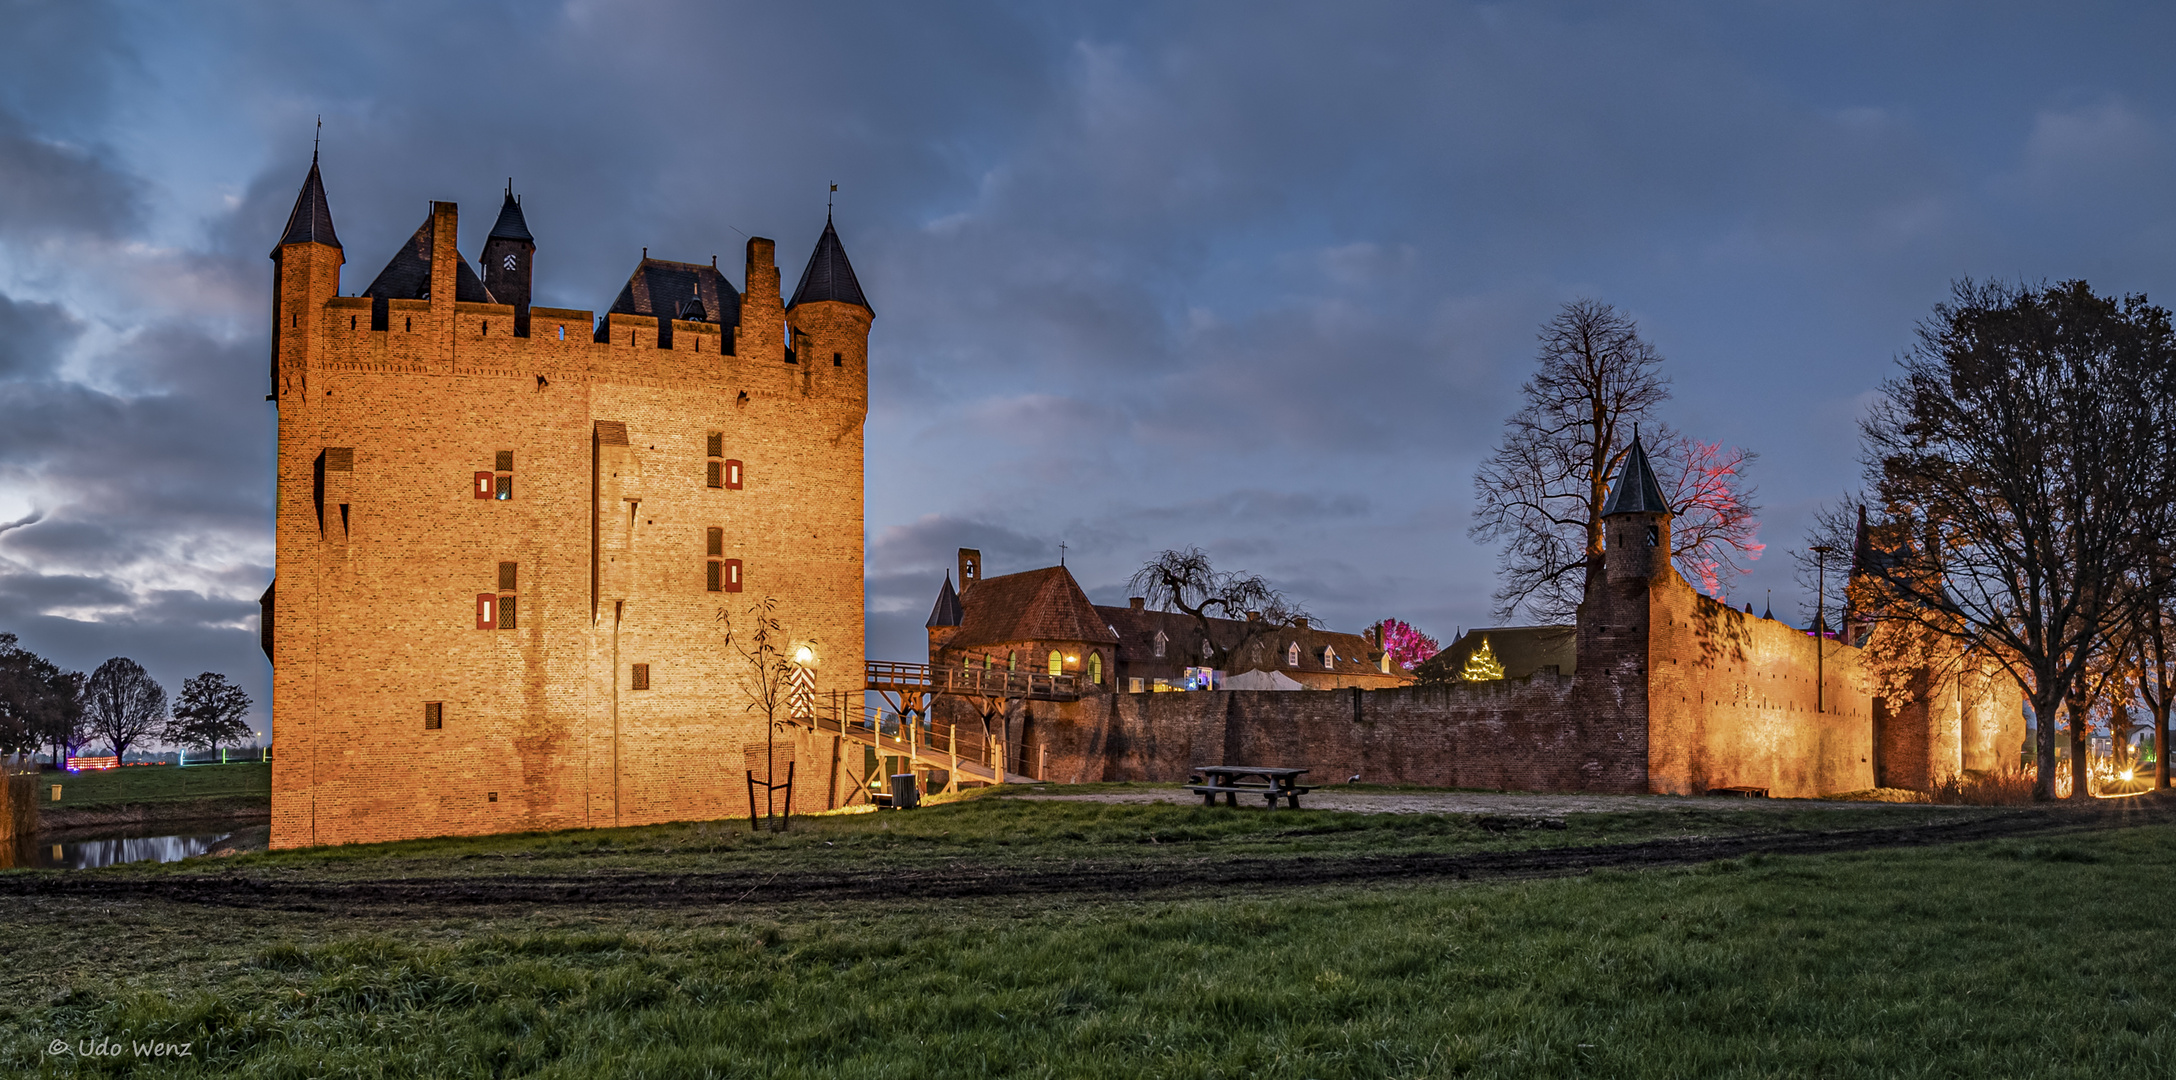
[905,440,2024,797]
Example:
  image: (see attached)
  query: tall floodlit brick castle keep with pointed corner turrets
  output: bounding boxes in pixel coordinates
[261,159,875,847]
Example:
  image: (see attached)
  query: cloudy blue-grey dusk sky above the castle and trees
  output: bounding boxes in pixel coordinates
[0,0,2176,740]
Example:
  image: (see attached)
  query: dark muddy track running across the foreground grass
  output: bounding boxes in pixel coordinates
[0,806,2176,912]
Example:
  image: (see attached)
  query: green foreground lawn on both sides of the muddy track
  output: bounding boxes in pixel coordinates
[0,799,2176,1080]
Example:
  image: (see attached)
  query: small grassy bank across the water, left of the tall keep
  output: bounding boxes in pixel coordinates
[37,762,272,830]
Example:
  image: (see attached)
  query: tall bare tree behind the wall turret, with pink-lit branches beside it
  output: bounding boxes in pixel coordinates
[1471,300,1760,621]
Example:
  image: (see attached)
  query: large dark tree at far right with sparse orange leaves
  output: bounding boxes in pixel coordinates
[1863,281,2176,799]
